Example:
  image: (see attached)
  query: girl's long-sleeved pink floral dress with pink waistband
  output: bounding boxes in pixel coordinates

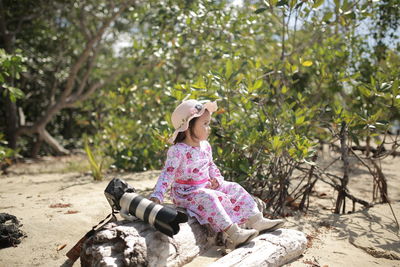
[150,141,259,232]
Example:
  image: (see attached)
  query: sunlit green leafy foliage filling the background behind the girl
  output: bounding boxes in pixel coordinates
[1,0,400,214]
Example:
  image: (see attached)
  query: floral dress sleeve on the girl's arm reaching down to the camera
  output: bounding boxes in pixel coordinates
[150,146,182,202]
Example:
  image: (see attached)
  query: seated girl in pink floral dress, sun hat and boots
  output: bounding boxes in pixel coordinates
[150,100,283,248]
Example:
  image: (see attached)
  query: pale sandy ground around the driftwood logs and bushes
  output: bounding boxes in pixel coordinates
[0,153,400,267]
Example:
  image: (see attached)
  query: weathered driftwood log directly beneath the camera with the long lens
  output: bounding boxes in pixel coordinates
[80,218,217,267]
